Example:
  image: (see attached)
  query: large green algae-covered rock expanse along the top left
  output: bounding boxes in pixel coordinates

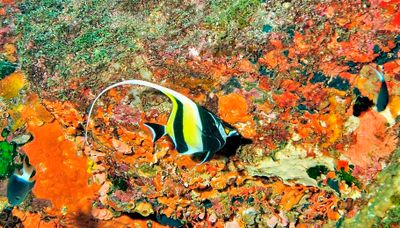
[15,0,268,100]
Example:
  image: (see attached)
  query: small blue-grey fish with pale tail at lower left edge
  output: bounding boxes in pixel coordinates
[7,156,35,206]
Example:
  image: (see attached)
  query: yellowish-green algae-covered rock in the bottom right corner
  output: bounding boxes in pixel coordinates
[343,149,400,227]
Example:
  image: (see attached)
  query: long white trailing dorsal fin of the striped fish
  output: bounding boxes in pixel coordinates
[84,79,196,144]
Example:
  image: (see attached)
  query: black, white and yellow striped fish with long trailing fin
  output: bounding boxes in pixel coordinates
[85,80,239,163]
